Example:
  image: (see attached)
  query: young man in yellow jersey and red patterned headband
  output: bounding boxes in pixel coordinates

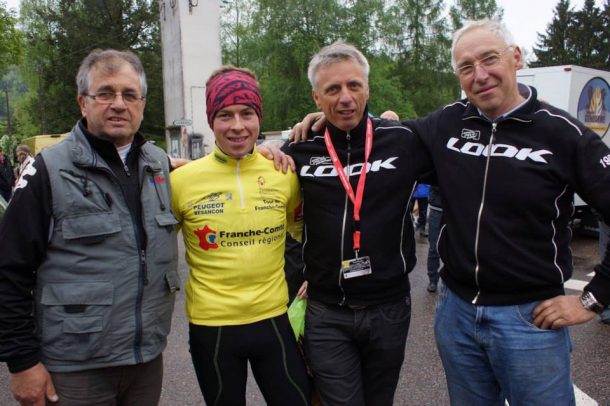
[171,66,310,406]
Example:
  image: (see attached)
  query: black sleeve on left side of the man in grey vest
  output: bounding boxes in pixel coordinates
[0,155,52,372]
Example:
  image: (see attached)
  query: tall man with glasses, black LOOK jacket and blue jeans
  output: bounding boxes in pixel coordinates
[295,20,610,405]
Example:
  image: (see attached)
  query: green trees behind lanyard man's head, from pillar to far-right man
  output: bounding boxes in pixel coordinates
[221,0,468,127]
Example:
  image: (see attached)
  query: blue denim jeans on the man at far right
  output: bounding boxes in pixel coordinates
[434,284,576,406]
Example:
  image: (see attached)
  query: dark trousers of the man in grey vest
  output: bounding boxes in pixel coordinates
[51,349,163,406]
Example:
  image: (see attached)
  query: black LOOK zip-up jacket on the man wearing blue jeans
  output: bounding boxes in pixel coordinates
[406,88,610,305]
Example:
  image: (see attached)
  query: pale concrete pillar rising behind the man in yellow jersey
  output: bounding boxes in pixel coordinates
[159,0,222,158]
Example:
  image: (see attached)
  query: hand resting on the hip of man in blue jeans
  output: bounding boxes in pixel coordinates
[533,295,595,329]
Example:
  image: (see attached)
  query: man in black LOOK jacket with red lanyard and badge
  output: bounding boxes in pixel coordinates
[286,43,430,406]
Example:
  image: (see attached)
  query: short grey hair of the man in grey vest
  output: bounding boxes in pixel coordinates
[76,49,148,96]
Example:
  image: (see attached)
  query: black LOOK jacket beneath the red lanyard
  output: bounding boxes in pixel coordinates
[284,112,431,305]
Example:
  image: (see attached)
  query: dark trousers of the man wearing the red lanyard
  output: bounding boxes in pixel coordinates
[305,297,411,406]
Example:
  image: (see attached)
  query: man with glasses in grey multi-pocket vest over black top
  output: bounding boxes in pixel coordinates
[0,50,179,406]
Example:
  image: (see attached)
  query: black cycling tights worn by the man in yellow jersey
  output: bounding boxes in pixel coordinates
[189,314,311,406]
